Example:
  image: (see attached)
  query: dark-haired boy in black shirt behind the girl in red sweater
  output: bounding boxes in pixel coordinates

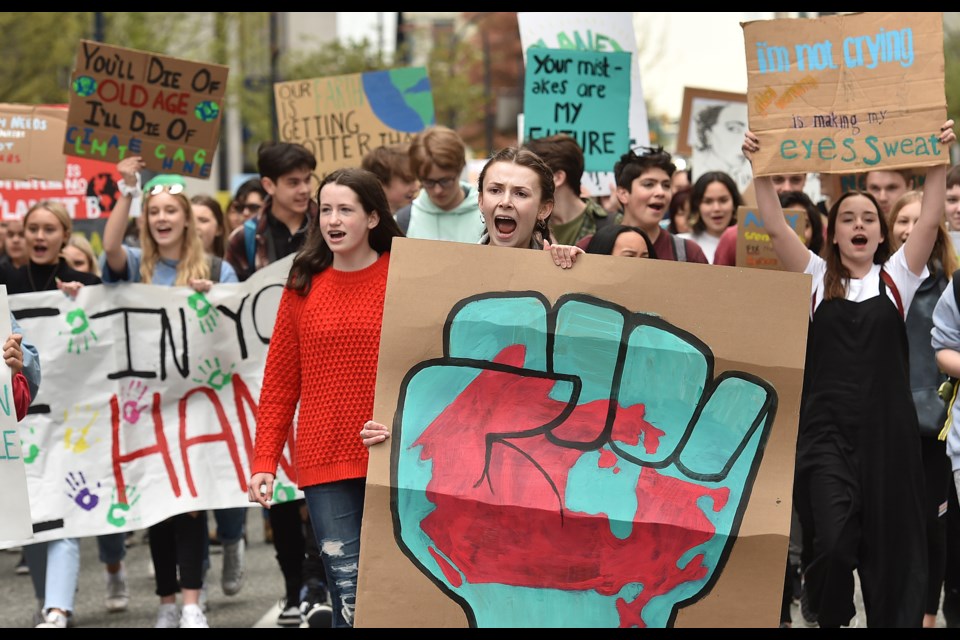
[226,142,317,282]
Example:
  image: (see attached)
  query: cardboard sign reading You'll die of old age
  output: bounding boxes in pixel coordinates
[63,40,228,178]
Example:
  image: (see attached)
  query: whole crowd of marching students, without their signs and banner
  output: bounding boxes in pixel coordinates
[0,109,960,628]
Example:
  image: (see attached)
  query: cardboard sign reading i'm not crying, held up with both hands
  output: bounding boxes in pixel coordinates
[743,11,950,175]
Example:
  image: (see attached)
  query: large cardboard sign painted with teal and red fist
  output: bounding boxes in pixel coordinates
[356,239,810,627]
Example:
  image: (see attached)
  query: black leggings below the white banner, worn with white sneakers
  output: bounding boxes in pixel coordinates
[149,511,207,598]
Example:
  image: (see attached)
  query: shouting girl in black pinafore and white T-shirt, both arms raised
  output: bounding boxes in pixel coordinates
[743,121,956,627]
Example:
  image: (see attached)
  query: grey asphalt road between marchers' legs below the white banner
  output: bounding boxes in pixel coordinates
[0,507,296,628]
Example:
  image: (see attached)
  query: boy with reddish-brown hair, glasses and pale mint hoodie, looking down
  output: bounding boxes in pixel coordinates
[397,125,485,244]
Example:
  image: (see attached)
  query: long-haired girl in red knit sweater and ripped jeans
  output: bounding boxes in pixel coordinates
[248,168,403,627]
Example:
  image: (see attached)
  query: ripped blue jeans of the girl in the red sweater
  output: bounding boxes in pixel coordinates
[303,478,366,627]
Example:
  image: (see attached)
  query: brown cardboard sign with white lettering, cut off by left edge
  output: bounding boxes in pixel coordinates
[0,104,67,180]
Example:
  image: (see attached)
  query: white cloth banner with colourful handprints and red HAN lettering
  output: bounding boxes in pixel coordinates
[0,258,301,548]
